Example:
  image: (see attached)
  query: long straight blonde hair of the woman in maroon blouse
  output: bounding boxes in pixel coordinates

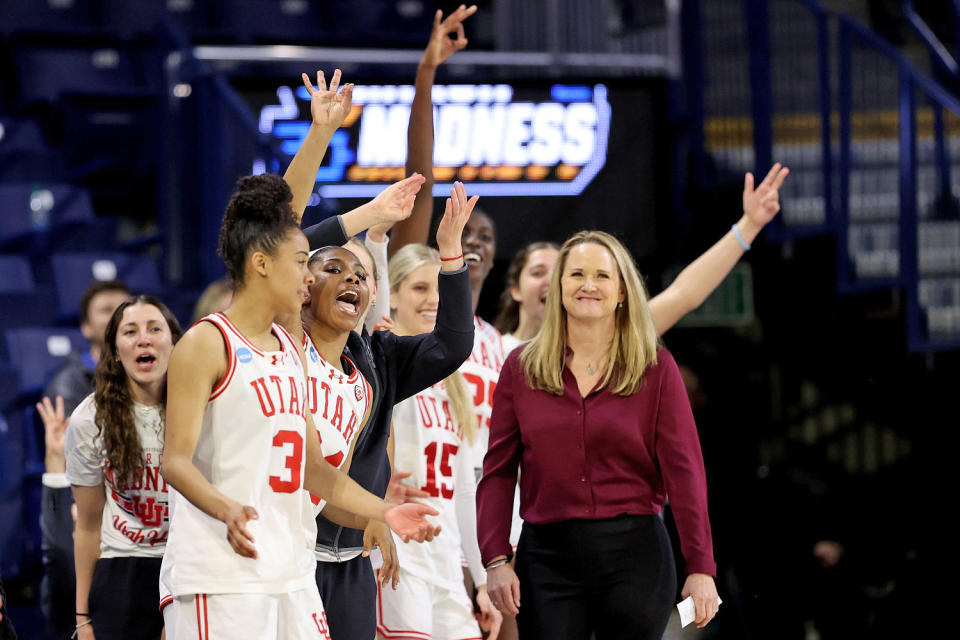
[520,231,658,396]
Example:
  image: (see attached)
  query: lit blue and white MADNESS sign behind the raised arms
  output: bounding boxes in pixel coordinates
[253,84,611,198]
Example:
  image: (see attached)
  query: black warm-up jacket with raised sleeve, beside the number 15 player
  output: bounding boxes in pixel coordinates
[304,216,473,555]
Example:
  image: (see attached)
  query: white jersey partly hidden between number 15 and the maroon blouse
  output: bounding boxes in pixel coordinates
[460,316,506,472]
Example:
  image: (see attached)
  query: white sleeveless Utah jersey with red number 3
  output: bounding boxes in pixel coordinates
[160,313,316,596]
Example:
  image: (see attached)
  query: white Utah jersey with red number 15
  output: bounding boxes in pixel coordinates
[393,382,480,589]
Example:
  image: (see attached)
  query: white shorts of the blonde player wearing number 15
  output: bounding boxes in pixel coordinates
[377,567,482,640]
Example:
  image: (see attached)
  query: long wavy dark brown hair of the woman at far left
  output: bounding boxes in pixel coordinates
[93,295,183,490]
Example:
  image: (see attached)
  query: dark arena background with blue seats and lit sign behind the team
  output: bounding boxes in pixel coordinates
[0,0,948,640]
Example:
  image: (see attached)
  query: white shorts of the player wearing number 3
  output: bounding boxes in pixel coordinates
[163,587,330,640]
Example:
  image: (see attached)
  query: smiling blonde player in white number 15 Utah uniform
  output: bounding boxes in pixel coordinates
[377,244,501,640]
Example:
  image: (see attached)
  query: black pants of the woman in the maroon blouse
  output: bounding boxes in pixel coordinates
[517,516,677,640]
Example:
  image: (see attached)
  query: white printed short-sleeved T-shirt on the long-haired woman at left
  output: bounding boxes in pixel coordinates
[64,394,169,558]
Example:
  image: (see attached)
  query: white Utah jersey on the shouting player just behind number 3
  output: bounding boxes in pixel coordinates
[303,332,370,516]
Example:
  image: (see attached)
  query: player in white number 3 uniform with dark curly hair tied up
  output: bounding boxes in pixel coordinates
[161,171,434,640]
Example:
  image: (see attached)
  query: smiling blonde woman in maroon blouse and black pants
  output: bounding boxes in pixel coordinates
[477,231,718,640]
